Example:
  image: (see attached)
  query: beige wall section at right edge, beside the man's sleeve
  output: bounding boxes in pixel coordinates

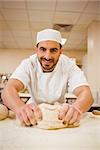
[83,21,100,103]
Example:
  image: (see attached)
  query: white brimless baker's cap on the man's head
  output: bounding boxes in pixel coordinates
[36,29,62,45]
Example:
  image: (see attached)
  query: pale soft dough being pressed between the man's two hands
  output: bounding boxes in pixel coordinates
[37,103,79,130]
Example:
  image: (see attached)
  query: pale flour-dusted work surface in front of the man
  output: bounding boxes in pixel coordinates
[0,112,100,150]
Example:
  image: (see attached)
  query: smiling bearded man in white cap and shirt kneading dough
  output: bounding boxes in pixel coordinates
[2,29,93,126]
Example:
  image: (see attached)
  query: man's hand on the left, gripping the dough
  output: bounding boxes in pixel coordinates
[16,103,42,126]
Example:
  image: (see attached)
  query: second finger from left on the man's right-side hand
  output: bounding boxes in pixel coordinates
[63,106,74,124]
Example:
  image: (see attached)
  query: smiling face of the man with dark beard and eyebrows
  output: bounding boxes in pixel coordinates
[36,41,62,72]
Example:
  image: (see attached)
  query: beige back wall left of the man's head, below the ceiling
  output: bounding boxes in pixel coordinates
[0,49,33,73]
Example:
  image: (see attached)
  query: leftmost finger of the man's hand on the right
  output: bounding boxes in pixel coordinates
[58,103,69,120]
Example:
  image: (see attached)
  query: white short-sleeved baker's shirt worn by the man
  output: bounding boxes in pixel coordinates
[10,54,88,104]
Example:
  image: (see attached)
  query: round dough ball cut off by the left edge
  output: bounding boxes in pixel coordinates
[0,104,8,120]
